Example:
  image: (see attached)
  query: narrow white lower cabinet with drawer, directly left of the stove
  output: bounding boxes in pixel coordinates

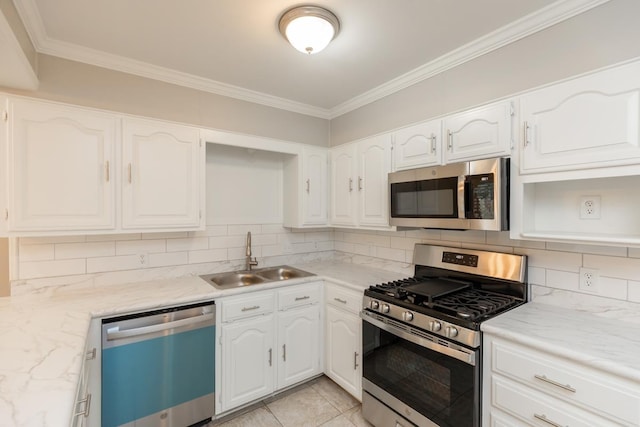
[325,284,362,400]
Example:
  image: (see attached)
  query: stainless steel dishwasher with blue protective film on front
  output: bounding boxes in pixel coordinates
[102,301,216,427]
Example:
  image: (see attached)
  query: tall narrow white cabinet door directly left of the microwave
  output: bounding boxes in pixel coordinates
[357,135,391,228]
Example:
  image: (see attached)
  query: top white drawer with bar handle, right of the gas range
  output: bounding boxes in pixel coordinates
[492,341,640,426]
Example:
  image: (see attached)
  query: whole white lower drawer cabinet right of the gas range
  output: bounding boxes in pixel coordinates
[483,333,640,427]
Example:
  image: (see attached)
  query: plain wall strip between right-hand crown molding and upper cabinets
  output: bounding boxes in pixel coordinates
[330,0,640,146]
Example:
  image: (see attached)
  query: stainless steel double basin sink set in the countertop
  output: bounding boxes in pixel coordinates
[200,265,315,290]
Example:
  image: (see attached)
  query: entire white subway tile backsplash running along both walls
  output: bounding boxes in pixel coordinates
[12,224,640,316]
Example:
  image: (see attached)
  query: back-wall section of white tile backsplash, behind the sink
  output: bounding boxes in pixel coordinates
[12,224,333,295]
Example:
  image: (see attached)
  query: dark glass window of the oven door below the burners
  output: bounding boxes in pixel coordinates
[363,321,480,427]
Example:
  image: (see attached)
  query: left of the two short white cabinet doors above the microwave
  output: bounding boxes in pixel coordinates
[393,120,442,170]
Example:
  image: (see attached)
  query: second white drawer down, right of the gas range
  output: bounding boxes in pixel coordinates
[491,377,619,427]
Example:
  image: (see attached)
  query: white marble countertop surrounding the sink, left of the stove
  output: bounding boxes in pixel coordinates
[0,262,403,427]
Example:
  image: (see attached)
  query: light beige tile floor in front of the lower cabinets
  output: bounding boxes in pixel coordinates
[208,376,371,427]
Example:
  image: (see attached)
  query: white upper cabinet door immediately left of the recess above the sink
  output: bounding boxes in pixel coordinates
[122,119,204,228]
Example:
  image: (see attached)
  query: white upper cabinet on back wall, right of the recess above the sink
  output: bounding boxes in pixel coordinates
[283,146,329,228]
